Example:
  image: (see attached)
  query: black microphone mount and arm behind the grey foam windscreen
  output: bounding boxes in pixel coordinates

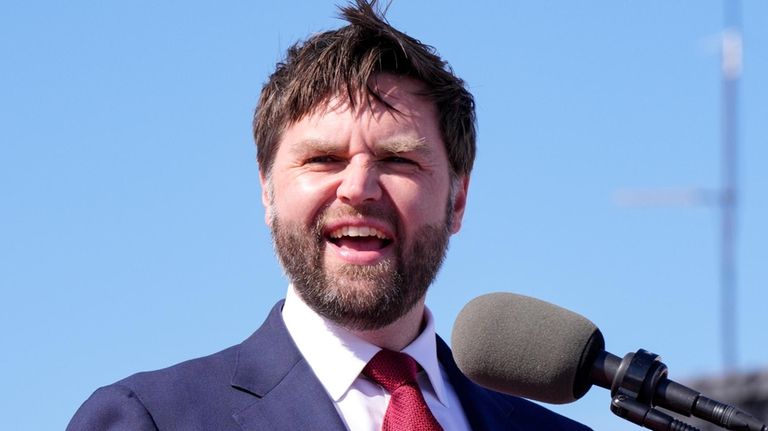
[591,349,768,431]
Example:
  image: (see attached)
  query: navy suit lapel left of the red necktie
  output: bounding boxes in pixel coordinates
[232,301,346,431]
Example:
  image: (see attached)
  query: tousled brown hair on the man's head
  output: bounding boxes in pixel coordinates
[253,0,476,175]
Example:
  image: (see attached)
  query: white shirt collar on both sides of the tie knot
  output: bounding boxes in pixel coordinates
[283,285,448,407]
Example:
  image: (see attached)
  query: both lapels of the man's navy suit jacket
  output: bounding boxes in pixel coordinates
[232,301,519,431]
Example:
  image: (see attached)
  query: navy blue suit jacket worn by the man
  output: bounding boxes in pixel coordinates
[67,301,589,431]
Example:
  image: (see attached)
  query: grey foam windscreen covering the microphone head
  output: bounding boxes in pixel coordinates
[451,293,605,404]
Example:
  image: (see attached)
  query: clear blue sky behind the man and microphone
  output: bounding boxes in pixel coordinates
[0,0,768,430]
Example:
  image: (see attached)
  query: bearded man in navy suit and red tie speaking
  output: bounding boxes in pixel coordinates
[68,0,587,430]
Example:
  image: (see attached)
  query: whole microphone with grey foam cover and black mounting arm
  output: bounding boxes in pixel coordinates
[451,292,768,431]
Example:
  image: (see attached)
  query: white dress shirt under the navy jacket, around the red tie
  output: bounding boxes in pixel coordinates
[283,286,470,431]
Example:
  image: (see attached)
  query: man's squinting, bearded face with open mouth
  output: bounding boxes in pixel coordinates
[261,74,468,330]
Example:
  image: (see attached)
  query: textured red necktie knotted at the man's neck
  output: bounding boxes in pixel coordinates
[363,349,443,431]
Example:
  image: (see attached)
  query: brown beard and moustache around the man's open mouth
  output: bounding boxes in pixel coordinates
[271,199,453,330]
